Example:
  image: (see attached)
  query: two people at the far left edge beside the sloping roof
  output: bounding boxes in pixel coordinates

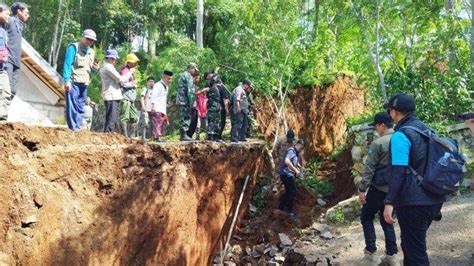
[0,2,30,121]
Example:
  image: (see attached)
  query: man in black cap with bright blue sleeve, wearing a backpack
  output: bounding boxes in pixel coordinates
[384,93,445,266]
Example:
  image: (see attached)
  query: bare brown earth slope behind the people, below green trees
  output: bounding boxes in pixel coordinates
[256,74,365,158]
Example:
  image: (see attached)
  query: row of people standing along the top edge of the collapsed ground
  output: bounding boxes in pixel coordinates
[63,29,253,143]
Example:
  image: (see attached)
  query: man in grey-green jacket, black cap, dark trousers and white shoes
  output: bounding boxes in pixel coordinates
[359,112,400,265]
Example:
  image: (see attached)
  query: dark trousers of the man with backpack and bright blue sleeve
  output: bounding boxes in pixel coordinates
[396,205,441,266]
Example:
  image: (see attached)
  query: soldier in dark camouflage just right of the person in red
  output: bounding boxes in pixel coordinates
[207,76,222,142]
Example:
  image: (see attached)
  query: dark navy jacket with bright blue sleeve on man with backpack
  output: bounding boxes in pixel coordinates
[386,115,445,207]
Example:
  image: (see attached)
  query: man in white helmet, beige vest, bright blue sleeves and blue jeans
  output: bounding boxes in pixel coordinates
[63,29,98,131]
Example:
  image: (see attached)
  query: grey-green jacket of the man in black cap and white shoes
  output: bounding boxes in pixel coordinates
[359,128,394,192]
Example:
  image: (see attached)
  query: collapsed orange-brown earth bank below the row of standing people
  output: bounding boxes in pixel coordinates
[0,124,266,265]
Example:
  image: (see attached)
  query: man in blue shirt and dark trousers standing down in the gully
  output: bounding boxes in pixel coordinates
[278,140,304,219]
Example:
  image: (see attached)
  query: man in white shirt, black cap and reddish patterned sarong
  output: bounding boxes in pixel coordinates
[146,70,173,141]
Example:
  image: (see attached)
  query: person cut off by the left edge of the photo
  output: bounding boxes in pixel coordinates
[0,4,12,121]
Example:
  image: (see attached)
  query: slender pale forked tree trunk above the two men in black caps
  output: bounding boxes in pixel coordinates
[350,0,388,102]
